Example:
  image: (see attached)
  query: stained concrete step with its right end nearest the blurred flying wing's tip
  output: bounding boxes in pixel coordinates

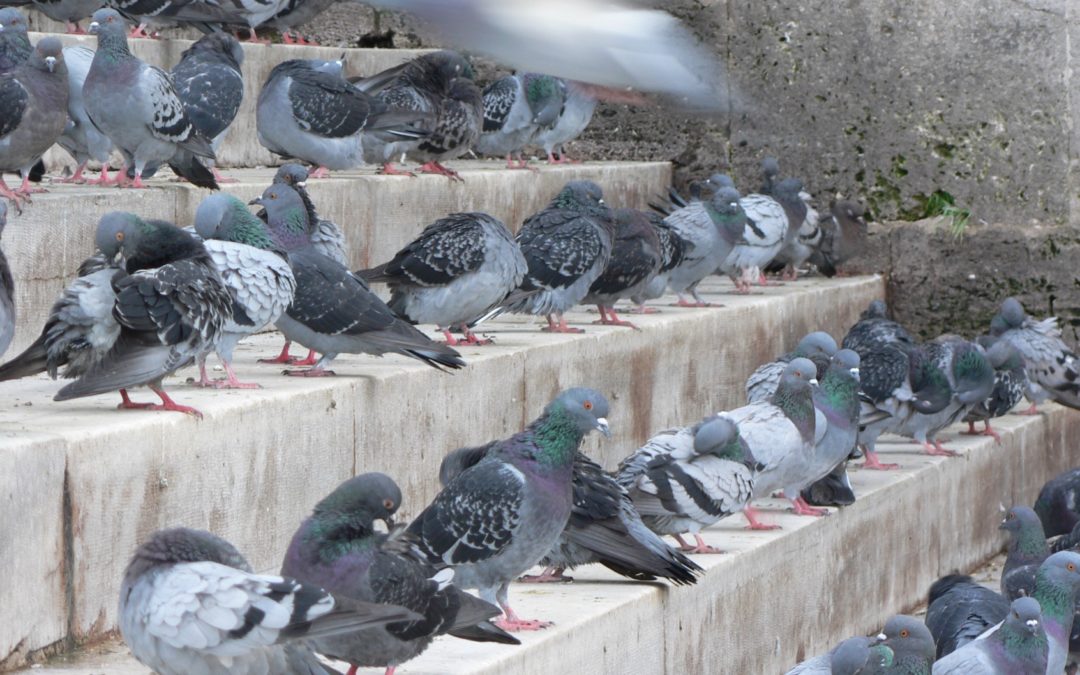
[2,161,671,357]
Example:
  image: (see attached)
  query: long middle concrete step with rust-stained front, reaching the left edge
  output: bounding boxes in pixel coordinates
[0,274,881,672]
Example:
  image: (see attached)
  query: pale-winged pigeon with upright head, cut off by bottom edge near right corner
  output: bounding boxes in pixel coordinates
[933,597,1050,675]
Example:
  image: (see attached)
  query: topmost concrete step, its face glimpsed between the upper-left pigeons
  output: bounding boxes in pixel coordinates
[30,33,429,175]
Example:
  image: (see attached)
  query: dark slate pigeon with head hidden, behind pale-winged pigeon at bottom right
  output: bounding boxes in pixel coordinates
[927,575,1009,659]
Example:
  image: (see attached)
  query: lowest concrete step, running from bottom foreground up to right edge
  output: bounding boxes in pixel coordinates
[16,382,1080,675]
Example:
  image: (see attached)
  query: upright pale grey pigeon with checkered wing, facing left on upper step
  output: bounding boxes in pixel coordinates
[83,8,217,189]
